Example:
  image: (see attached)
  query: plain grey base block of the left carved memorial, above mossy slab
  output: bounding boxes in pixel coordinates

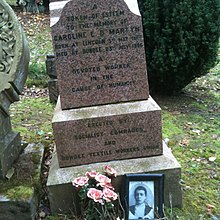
[0,131,21,179]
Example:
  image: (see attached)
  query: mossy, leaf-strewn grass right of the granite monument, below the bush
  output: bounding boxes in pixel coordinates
[158,65,220,220]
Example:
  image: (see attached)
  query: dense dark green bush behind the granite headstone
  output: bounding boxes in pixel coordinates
[139,0,220,94]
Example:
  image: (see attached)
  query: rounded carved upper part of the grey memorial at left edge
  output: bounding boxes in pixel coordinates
[0,0,29,94]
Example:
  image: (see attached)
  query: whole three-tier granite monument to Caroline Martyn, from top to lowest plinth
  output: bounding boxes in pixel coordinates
[47,0,181,212]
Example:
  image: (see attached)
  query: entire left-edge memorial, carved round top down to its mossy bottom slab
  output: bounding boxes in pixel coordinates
[0,0,44,220]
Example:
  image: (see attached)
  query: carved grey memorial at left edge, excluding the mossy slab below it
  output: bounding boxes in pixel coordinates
[0,1,29,178]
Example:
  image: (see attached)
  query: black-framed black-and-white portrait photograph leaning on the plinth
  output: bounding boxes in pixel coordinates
[122,174,164,220]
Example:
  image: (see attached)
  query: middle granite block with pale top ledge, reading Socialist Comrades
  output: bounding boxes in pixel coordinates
[52,97,163,167]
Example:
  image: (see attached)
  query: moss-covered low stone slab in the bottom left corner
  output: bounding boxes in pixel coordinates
[0,143,44,220]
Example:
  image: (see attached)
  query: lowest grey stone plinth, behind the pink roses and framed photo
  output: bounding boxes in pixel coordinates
[47,143,182,213]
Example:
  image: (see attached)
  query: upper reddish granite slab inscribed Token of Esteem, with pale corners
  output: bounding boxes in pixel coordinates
[50,0,149,109]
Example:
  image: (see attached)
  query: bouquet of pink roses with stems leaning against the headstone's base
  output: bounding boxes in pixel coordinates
[72,166,119,220]
